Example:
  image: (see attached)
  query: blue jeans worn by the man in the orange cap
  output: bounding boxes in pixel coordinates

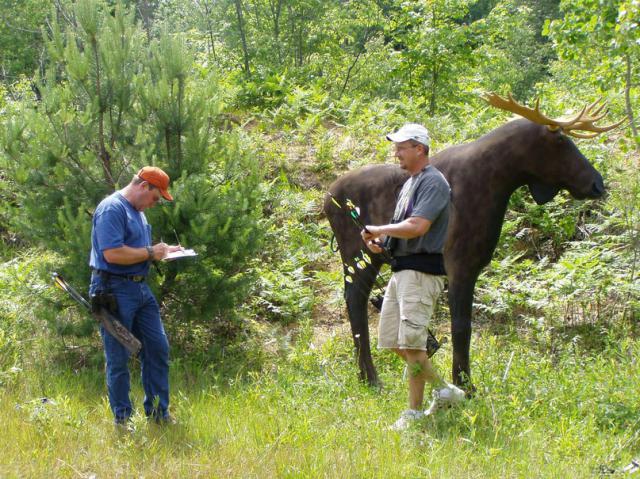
[89,273,169,422]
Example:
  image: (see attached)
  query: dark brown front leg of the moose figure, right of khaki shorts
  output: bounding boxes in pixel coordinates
[449,278,475,394]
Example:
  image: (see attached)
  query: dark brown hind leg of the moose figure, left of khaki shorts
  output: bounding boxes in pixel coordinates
[345,265,380,386]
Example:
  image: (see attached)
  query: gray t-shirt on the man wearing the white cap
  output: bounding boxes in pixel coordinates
[392,165,451,256]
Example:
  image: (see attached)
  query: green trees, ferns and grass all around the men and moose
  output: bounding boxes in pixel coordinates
[0,0,640,477]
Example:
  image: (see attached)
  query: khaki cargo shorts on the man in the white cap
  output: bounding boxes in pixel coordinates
[378,269,444,351]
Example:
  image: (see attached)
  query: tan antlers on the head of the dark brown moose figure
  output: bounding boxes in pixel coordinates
[482,93,625,138]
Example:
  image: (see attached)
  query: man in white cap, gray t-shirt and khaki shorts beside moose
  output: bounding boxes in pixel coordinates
[361,123,464,430]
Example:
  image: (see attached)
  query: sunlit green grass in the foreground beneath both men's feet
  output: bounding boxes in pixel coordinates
[0,320,640,478]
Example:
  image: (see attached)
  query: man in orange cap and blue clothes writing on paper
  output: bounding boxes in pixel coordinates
[89,166,181,424]
